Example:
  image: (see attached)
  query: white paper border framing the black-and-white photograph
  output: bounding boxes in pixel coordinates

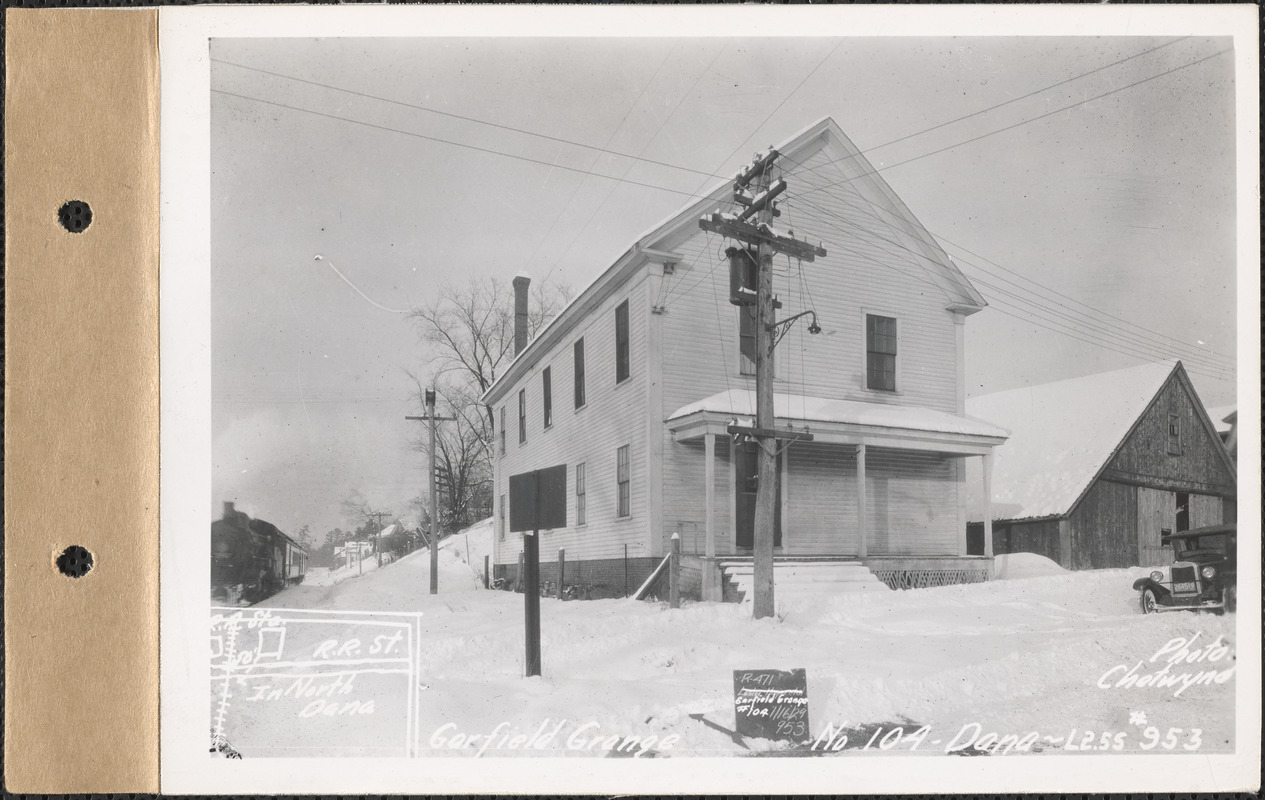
[159,5,1261,794]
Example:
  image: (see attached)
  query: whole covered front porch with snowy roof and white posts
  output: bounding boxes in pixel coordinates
[664,390,1007,597]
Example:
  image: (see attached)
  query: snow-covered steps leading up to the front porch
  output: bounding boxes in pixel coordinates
[720,558,891,605]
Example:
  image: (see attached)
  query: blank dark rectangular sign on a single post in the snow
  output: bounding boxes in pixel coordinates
[510,465,567,677]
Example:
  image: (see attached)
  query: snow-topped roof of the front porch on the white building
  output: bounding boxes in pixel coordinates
[667,389,1009,454]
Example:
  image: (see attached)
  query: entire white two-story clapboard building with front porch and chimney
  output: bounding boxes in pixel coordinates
[483,119,1006,596]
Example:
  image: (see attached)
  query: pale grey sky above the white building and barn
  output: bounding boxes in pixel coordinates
[210,35,1236,537]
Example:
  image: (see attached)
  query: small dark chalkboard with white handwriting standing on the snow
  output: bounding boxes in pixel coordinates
[734,670,812,742]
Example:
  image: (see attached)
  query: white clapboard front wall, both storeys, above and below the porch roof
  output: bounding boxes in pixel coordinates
[662,143,960,554]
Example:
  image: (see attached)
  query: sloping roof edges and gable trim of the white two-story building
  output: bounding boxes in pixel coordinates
[482,116,988,404]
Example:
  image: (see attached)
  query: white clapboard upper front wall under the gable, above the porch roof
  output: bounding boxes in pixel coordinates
[663,144,958,415]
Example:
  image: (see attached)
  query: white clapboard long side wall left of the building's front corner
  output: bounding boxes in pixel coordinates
[493,270,649,563]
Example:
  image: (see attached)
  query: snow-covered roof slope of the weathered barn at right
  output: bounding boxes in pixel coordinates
[966,361,1178,522]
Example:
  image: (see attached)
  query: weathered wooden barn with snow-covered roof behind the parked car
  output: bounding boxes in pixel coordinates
[966,362,1236,570]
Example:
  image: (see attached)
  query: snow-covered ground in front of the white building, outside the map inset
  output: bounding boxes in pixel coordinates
[213,522,1236,758]
